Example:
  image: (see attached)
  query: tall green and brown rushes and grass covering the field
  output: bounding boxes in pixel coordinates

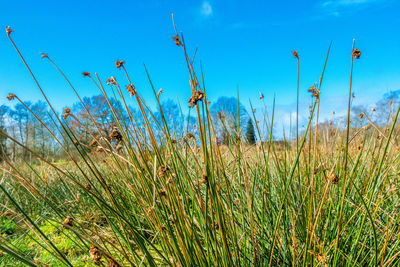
[0,19,400,266]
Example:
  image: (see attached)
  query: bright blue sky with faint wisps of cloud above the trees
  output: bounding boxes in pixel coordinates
[0,0,400,133]
